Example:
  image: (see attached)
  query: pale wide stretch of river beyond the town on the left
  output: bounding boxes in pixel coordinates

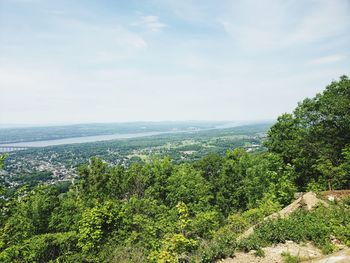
[0,132,174,147]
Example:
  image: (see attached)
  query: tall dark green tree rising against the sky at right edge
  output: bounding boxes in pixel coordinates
[266,76,350,190]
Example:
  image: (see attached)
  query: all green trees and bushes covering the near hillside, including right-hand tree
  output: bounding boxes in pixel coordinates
[0,76,350,263]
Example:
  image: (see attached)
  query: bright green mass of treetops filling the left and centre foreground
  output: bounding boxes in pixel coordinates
[0,152,295,262]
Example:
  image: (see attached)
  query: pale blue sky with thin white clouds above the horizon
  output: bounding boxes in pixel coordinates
[0,0,350,124]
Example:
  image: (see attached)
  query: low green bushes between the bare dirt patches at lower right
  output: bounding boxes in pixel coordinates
[239,204,350,253]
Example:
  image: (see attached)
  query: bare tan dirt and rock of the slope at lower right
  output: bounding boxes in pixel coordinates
[218,193,350,263]
